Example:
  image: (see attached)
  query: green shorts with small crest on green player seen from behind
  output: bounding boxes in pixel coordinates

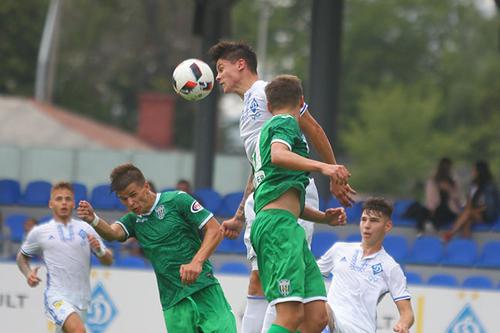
[250,209,326,305]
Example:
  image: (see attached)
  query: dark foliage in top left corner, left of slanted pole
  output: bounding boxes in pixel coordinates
[0,0,48,96]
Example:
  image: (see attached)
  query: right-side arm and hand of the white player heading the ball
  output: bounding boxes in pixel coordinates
[299,109,356,207]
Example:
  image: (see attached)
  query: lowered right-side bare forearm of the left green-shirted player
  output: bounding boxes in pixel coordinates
[180,217,224,284]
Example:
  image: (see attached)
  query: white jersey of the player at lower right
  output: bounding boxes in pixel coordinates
[318,242,410,333]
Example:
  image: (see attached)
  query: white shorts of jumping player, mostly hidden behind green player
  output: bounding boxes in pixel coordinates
[244,178,319,271]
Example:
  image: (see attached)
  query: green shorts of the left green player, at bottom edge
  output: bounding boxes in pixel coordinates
[163,284,236,333]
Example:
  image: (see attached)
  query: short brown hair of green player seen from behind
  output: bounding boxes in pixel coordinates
[265,75,303,112]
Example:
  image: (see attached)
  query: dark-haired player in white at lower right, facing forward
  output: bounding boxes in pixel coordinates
[318,198,414,333]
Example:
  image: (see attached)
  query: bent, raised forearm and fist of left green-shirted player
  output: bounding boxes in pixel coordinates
[76,200,127,241]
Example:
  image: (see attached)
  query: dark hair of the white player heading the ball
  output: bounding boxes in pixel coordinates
[208,41,257,74]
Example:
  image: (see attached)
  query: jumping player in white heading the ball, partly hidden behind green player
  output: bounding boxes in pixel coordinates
[209,41,355,333]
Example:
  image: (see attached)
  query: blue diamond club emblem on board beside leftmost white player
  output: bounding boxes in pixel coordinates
[86,282,118,333]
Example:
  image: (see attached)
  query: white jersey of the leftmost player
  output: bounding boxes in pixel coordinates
[21,219,106,309]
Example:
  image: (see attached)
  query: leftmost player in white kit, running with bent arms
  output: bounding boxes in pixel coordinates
[17,182,113,333]
